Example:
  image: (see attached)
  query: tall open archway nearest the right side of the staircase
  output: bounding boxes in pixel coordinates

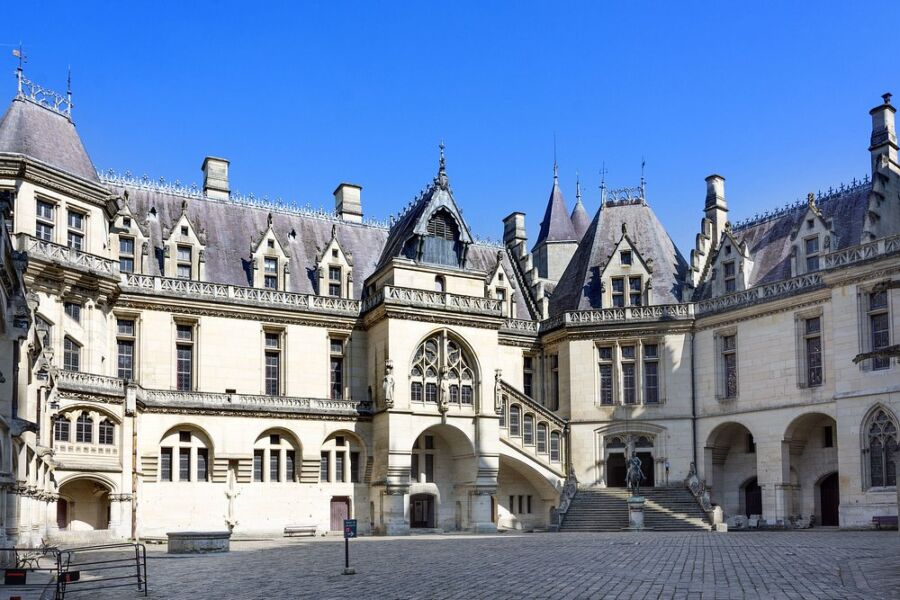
[704,422,762,514]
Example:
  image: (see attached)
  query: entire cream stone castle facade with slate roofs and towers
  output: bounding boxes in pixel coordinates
[0,72,900,544]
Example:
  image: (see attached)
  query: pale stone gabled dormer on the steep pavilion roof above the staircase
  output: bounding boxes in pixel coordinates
[600,223,653,308]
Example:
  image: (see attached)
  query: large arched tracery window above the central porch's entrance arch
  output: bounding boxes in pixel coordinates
[409,332,475,406]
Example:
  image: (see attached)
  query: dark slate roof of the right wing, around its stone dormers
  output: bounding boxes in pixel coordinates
[695,183,872,299]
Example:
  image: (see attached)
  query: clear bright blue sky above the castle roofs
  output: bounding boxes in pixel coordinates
[0,1,900,255]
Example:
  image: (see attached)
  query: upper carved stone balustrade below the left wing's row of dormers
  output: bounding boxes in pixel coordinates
[120,273,360,317]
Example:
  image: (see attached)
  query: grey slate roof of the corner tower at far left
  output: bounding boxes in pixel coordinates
[0,98,100,183]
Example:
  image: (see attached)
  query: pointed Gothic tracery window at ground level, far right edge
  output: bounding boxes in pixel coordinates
[860,402,900,491]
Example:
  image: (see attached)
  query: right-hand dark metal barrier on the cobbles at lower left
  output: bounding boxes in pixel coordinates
[56,543,147,600]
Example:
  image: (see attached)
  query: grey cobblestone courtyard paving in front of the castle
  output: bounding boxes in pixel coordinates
[79,531,900,600]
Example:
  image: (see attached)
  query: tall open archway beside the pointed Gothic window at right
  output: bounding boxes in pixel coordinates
[784,412,839,523]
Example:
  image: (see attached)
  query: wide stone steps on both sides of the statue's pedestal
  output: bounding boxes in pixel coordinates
[560,488,711,531]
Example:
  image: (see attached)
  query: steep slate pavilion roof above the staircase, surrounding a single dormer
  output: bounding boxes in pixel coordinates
[550,202,688,316]
